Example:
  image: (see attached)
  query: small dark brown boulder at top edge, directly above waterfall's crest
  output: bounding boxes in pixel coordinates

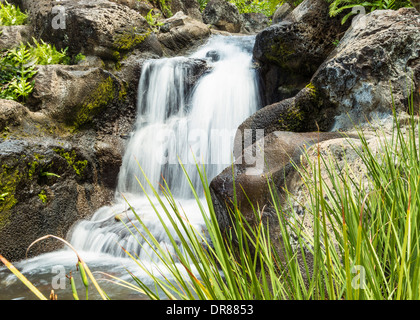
[203,0,243,33]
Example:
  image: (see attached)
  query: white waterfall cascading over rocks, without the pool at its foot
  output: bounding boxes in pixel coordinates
[67,36,260,259]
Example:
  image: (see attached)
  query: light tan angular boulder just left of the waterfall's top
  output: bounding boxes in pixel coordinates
[158,11,211,55]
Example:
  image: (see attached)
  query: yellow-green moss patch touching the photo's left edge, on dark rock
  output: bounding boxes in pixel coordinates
[0,165,21,229]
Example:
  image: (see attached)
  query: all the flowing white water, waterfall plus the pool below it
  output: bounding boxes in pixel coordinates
[0,36,260,300]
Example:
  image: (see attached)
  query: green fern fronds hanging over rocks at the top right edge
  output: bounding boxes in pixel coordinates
[327,0,411,24]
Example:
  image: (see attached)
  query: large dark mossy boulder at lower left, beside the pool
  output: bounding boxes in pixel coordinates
[0,137,117,261]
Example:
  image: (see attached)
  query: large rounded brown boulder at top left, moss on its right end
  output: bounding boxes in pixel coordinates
[26,0,150,60]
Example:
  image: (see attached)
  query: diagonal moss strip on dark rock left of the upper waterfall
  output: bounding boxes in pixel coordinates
[71,77,117,131]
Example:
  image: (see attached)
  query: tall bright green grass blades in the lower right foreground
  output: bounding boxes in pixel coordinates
[104,95,420,300]
